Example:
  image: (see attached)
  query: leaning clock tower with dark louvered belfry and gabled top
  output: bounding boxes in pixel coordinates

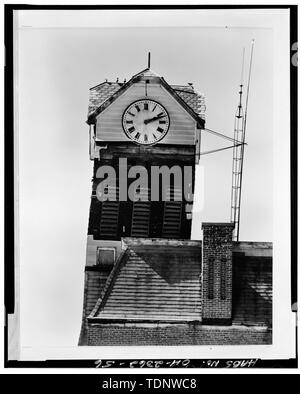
[79,64,205,345]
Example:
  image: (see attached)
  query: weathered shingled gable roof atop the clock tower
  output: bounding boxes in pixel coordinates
[88,69,206,124]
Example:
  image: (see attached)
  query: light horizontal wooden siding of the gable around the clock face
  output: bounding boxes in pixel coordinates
[96,83,196,145]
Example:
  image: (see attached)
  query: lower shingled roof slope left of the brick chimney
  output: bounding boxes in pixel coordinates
[93,241,201,321]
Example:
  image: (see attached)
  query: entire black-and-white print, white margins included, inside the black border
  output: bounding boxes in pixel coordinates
[8,4,295,361]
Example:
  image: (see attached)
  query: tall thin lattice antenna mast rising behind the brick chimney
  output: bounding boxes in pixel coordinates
[230,40,254,241]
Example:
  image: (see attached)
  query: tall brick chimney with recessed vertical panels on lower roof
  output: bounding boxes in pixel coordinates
[202,223,234,325]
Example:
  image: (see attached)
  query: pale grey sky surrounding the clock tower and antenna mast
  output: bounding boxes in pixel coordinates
[16,10,273,347]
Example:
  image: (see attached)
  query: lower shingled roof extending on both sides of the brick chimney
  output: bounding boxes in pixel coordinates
[89,238,272,327]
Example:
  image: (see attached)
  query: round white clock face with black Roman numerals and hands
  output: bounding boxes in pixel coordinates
[122,99,170,145]
